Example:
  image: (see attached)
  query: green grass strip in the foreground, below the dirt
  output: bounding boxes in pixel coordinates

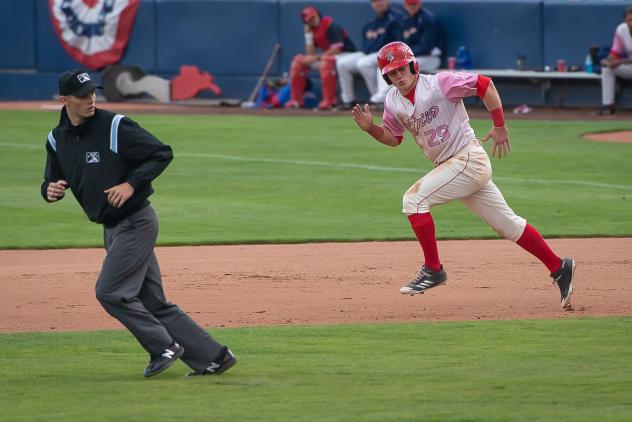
[0,318,632,421]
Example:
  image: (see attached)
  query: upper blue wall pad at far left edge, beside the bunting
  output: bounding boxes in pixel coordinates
[0,0,35,69]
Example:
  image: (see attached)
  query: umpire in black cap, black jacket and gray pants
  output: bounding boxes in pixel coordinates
[41,70,237,377]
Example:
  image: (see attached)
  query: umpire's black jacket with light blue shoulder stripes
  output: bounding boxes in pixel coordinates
[41,107,173,227]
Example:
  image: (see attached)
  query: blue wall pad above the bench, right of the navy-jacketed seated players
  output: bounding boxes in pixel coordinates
[423,0,543,69]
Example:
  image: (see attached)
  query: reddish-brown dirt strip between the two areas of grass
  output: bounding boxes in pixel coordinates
[0,238,632,332]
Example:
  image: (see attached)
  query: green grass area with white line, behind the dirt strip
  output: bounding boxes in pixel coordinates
[0,111,632,248]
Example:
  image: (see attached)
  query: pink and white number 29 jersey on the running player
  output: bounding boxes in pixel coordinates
[382,72,478,165]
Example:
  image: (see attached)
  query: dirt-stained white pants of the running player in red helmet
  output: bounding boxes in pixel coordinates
[402,139,527,242]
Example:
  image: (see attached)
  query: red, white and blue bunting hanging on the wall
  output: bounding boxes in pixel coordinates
[48,0,140,69]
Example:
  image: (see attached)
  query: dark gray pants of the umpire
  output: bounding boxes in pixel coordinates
[96,206,222,371]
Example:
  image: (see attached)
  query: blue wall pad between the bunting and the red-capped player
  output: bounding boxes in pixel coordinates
[156,0,278,76]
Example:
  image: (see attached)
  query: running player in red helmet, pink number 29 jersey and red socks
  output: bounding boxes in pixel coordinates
[352,42,575,309]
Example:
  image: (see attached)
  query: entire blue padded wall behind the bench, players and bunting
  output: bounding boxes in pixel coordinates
[0,0,632,105]
